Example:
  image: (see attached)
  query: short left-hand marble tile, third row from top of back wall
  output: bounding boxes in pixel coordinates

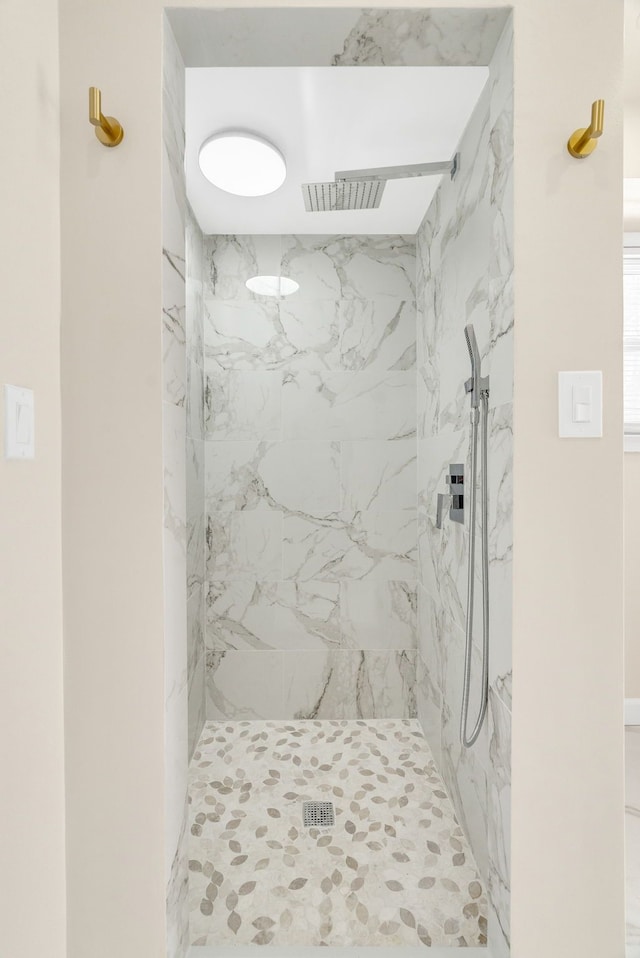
[204,370,282,440]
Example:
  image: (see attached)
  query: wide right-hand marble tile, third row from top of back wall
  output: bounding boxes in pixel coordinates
[282,370,416,439]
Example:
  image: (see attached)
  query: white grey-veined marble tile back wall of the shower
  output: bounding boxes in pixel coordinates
[204,236,417,720]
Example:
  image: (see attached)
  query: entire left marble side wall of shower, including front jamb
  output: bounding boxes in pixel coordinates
[162,16,205,958]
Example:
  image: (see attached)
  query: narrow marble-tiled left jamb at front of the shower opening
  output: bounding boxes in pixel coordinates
[162,20,189,958]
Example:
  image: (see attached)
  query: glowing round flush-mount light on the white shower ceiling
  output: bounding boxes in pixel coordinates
[198,130,287,196]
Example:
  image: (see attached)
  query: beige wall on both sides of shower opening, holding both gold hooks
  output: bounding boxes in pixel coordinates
[61,0,624,958]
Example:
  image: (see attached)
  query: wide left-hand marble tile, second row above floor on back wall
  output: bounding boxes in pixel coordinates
[207,581,342,651]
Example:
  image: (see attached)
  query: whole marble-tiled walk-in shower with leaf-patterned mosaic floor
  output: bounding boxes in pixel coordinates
[163,7,512,958]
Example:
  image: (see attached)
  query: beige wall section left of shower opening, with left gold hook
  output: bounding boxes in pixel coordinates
[60,0,165,958]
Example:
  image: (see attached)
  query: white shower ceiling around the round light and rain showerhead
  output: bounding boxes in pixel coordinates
[185,67,489,234]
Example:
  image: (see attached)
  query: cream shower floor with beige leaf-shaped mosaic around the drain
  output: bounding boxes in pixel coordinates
[189,720,486,947]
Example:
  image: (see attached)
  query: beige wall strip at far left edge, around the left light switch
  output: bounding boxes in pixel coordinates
[0,0,66,958]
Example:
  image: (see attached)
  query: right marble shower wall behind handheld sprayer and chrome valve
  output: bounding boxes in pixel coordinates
[417,16,513,958]
